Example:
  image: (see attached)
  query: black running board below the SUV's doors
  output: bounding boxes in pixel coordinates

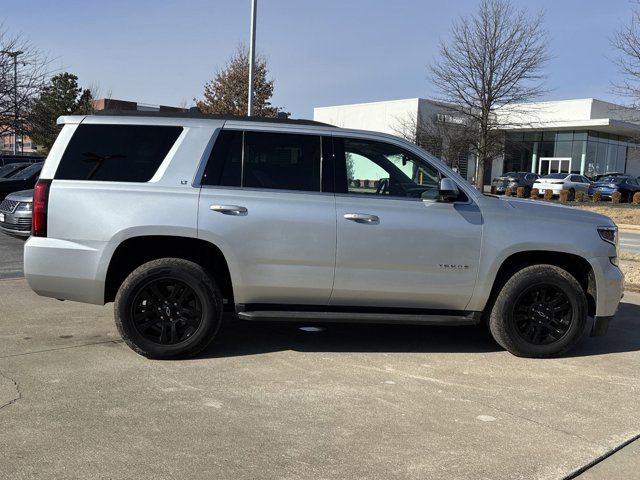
[237,310,481,325]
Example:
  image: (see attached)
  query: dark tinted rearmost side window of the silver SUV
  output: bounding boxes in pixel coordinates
[55,125,182,182]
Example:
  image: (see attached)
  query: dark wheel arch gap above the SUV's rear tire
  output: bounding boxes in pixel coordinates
[104,235,234,309]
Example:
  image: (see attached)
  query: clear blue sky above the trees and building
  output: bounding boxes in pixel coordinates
[0,0,632,118]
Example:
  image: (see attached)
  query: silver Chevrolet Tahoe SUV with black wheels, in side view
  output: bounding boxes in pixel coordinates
[24,112,623,358]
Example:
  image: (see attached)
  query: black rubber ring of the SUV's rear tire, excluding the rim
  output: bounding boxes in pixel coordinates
[115,261,222,358]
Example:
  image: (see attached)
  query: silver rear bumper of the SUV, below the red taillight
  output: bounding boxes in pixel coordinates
[24,237,105,305]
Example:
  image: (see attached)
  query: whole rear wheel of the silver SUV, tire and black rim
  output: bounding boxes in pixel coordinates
[115,258,223,359]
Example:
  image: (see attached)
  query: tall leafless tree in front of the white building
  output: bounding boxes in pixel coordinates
[431,0,549,189]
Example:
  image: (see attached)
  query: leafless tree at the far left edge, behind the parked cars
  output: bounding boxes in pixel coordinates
[0,24,49,149]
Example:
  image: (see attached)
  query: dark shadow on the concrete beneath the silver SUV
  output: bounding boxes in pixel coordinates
[197,303,640,359]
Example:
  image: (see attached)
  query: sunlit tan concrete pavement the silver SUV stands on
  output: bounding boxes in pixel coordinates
[0,236,640,479]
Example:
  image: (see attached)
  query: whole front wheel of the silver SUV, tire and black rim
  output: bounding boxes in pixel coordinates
[489,265,587,358]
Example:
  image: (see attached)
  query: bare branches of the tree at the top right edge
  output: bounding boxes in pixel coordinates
[611,1,640,106]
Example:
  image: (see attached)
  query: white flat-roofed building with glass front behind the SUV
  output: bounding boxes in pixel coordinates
[314,98,640,184]
